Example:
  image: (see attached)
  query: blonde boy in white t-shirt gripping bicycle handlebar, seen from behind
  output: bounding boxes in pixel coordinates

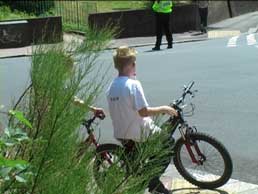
[107,46,177,194]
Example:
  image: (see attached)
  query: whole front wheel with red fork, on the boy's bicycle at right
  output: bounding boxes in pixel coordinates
[173,133,233,189]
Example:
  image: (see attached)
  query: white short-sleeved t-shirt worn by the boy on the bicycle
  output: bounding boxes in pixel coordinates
[107,76,160,141]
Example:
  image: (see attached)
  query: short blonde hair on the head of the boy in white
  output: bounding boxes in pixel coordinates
[113,46,137,71]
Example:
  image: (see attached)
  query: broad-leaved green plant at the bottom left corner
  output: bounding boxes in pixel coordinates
[0,111,33,194]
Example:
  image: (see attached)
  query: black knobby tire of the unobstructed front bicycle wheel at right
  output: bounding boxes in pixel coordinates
[173,132,233,189]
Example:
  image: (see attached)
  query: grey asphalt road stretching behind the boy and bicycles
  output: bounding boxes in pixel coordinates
[0,34,258,184]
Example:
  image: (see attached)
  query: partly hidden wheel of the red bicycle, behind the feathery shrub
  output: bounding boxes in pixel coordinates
[93,144,126,188]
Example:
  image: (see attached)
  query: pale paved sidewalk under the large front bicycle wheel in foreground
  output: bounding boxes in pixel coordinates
[145,165,258,194]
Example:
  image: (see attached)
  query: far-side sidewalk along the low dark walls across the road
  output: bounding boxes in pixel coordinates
[0,12,258,58]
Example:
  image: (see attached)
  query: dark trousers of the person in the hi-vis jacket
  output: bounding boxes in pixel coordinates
[155,13,173,47]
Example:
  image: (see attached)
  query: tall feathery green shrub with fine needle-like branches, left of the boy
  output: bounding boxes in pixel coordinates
[6,25,115,194]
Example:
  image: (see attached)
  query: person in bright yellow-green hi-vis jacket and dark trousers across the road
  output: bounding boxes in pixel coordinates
[152,0,173,51]
